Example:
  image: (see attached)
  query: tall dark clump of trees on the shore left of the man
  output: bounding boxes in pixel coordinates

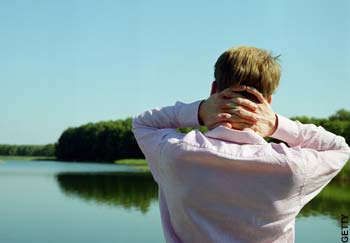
[56,118,144,162]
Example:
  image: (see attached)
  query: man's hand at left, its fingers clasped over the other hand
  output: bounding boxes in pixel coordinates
[198,86,258,130]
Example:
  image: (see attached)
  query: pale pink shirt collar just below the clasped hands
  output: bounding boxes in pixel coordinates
[205,125,267,145]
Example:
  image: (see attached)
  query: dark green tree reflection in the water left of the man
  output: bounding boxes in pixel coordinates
[57,172,158,213]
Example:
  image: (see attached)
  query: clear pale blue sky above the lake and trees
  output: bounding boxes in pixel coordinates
[0,0,350,144]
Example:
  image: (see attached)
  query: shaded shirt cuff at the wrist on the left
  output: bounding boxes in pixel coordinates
[175,100,202,127]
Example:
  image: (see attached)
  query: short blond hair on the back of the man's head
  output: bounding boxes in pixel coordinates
[214,46,281,98]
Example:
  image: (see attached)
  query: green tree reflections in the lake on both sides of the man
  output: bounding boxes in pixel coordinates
[57,172,350,221]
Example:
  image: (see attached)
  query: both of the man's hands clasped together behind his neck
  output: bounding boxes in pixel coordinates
[198,86,277,137]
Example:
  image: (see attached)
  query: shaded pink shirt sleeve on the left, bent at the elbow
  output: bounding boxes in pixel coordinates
[132,100,202,182]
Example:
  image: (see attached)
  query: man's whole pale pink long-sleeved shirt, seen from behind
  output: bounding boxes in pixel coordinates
[132,101,350,243]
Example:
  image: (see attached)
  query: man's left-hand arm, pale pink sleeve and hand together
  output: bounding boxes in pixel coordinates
[132,86,256,181]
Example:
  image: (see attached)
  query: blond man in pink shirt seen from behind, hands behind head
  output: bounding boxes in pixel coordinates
[132,47,350,243]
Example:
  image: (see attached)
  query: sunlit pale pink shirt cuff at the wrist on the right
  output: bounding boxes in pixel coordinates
[270,114,299,144]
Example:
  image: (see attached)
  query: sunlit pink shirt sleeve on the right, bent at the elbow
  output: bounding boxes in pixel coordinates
[271,115,350,206]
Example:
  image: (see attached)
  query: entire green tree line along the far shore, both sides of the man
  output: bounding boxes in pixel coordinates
[0,109,350,162]
